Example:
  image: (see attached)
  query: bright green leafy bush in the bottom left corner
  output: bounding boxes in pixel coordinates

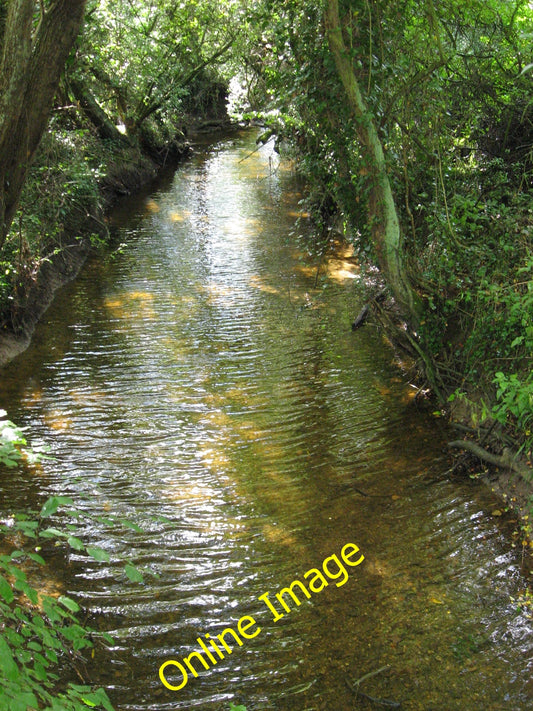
[0,497,113,711]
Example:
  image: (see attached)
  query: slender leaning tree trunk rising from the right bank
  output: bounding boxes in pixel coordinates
[324,0,421,327]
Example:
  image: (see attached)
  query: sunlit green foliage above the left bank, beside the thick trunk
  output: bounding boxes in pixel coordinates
[0,0,246,330]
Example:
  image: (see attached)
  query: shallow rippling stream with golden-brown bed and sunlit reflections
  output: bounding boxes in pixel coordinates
[0,135,533,711]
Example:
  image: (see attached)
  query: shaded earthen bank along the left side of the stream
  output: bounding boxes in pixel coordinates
[0,117,239,368]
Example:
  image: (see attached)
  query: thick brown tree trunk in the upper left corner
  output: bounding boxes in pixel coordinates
[0,0,86,248]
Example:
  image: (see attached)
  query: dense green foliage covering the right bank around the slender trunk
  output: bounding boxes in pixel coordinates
[239,0,533,443]
